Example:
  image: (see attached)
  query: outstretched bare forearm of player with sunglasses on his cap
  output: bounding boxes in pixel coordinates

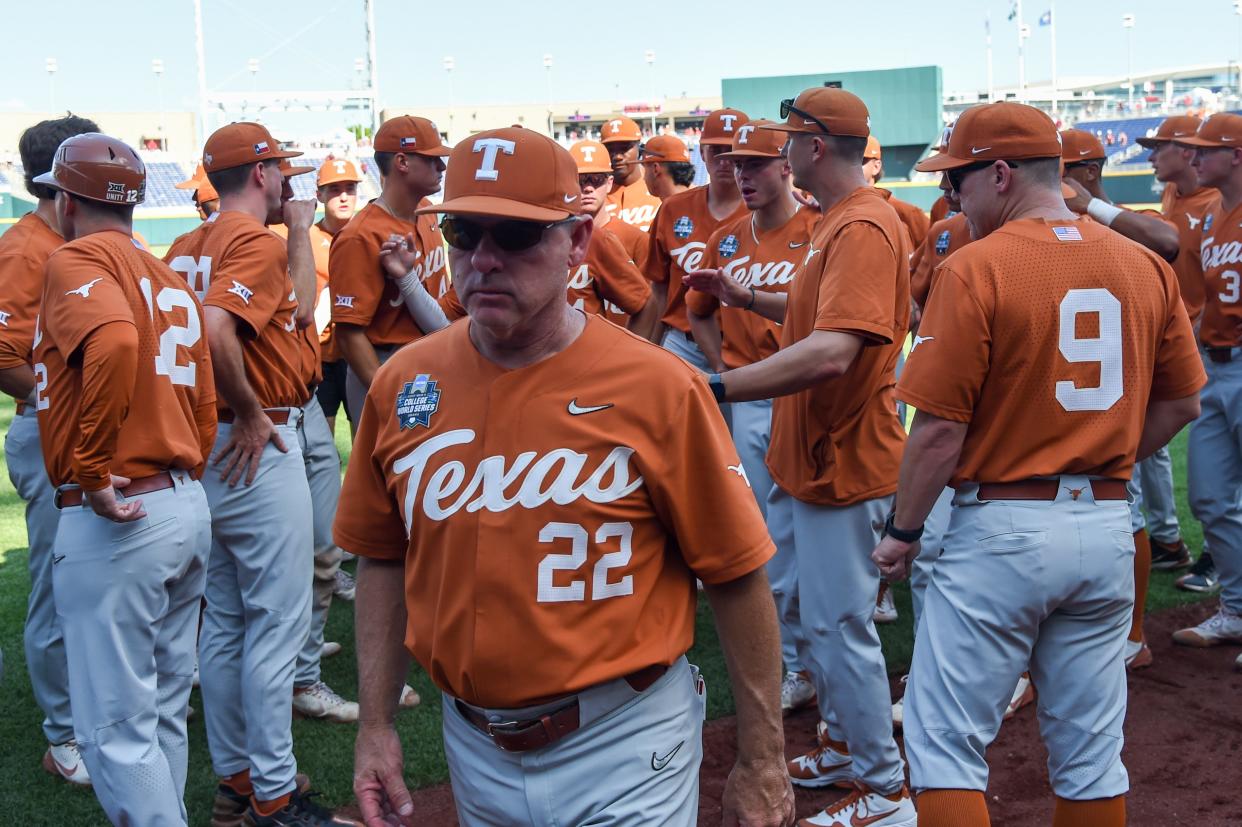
[723,330,862,402]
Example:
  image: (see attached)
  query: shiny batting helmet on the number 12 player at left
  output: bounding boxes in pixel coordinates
[35,132,147,206]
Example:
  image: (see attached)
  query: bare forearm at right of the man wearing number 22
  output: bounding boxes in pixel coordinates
[703,569,785,764]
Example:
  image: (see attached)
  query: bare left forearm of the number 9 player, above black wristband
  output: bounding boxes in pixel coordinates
[893,411,966,529]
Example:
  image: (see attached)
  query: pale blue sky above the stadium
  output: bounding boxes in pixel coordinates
[0,0,1242,128]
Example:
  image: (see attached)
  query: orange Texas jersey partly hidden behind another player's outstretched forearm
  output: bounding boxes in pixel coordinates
[686,207,820,370]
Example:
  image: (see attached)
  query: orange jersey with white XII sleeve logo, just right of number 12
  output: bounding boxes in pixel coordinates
[164,210,309,410]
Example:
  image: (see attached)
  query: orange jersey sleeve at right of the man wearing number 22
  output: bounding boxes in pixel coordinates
[640,376,775,584]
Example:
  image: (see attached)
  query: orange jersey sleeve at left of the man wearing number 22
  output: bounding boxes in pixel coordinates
[333,366,410,560]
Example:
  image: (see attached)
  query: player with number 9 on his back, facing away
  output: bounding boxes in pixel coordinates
[873,103,1203,827]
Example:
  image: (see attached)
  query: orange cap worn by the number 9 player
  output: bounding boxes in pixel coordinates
[914,101,1061,173]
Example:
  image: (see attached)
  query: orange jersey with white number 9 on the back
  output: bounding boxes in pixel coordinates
[897,219,1206,484]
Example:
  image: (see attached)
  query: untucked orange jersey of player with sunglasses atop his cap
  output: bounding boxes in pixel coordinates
[768,186,910,505]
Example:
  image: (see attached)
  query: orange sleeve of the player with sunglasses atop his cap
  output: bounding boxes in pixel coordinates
[815,221,909,344]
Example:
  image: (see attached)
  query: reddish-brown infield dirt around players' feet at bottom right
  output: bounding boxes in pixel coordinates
[392,598,1242,827]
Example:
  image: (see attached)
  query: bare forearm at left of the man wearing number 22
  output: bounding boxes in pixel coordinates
[354,558,410,725]
